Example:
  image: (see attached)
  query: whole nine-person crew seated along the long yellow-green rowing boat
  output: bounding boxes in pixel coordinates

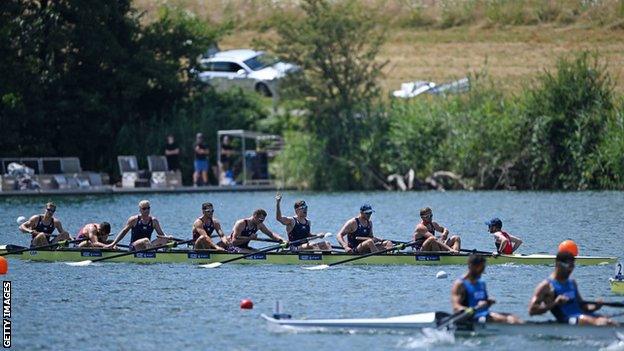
[20,201,522,254]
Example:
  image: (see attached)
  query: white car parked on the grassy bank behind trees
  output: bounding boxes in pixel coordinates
[197,49,296,98]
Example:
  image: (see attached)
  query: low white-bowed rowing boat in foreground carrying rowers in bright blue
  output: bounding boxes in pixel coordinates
[261,312,624,339]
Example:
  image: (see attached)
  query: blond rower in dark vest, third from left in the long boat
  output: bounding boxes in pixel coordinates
[104,200,172,251]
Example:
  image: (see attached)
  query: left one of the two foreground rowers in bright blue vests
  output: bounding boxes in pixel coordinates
[451,255,524,324]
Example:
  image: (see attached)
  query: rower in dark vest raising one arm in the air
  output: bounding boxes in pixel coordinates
[275,194,331,251]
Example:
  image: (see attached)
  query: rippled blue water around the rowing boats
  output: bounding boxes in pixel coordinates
[0,192,624,350]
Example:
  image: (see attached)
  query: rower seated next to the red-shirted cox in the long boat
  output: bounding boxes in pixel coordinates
[413,207,461,253]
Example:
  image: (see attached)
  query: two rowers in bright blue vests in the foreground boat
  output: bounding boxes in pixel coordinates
[451,251,618,326]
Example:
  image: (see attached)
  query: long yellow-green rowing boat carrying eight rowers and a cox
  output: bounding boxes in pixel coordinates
[0,245,616,265]
